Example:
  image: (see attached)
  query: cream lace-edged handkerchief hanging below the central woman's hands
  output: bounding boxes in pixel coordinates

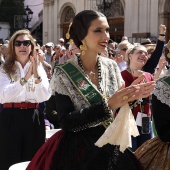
[95,104,139,152]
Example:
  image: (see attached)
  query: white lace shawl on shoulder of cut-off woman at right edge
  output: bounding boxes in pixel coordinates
[153,76,170,107]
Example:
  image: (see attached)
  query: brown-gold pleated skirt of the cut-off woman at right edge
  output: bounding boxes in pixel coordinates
[135,137,170,170]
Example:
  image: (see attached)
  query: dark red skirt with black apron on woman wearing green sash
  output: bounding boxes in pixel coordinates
[26,126,140,170]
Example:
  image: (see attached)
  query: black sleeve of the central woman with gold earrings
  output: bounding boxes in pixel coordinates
[55,93,110,131]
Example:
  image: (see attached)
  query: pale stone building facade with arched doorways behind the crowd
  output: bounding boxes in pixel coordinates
[43,0,170,44]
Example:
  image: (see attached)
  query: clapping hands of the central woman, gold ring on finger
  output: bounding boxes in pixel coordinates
[108,81,155,110]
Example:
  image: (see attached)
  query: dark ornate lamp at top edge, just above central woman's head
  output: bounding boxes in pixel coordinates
[96,0,114,17]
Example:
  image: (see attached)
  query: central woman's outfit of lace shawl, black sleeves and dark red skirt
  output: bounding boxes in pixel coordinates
[27,56,140,170]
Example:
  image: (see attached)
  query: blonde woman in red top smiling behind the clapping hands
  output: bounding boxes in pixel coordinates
[121,45,154,151]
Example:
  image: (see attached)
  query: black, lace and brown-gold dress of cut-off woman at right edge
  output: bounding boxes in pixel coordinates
[135,76,170,170]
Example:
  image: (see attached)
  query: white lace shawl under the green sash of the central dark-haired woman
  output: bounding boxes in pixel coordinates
[50,56,124,111]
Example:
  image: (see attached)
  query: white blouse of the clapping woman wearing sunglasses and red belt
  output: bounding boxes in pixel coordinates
[0,61,51,104]
